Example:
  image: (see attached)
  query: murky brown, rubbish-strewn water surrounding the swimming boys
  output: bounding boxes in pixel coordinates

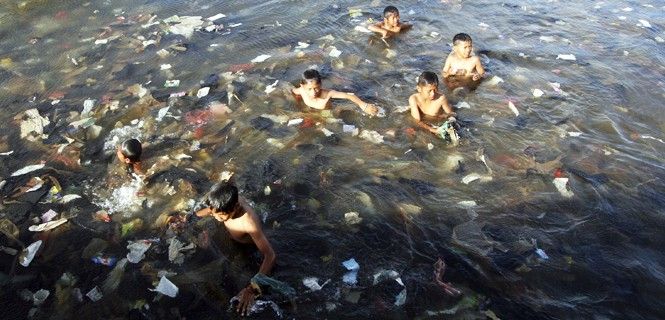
[0,1,665,319]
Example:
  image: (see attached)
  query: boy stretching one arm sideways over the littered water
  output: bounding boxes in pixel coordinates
[291,69,379,115]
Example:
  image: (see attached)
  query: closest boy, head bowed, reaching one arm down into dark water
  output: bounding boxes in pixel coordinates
[196,181,276,314]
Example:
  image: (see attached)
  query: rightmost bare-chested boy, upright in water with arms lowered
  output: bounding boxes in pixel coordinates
[442,33,485,81]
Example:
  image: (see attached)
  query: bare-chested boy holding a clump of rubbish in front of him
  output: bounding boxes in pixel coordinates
[409,71,455,135]
